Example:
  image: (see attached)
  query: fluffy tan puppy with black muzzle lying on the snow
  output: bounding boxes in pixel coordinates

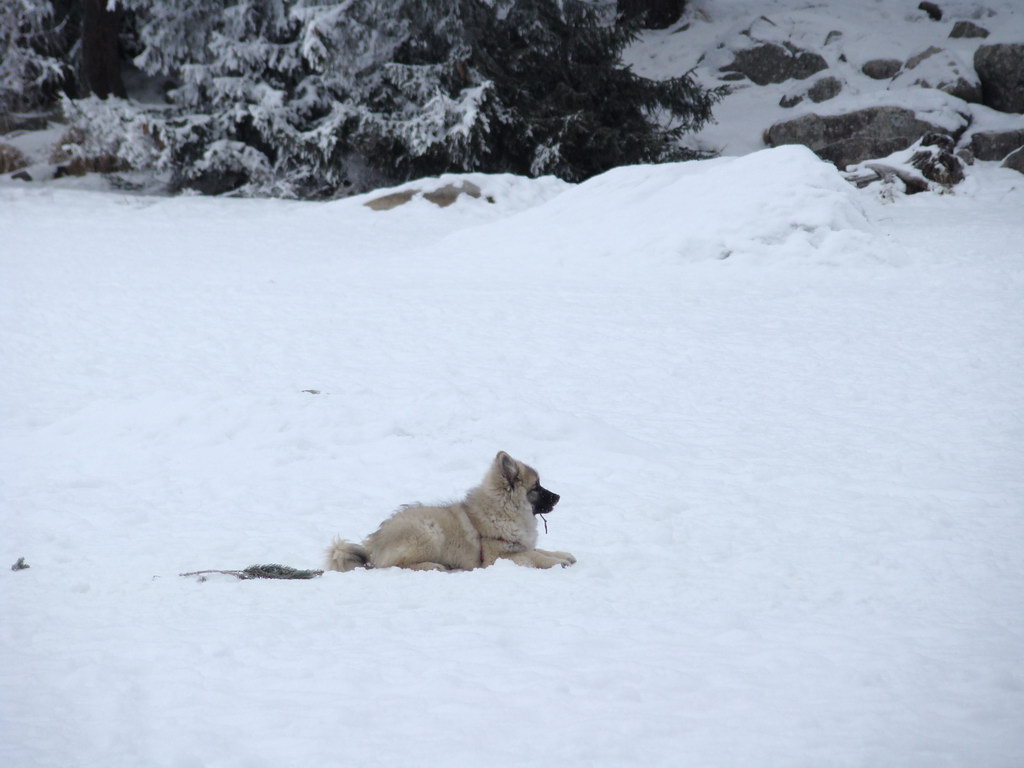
[326,451,575,571]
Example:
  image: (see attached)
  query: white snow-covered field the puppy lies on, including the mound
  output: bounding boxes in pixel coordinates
[0,147,1024,768]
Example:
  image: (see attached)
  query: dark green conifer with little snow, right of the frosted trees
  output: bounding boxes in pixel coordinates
[454,0,719,181]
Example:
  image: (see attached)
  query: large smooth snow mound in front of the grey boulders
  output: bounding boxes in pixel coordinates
[441,146,881,265]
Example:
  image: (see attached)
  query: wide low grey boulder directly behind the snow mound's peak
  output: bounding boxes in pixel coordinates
[764,106,947,170]
